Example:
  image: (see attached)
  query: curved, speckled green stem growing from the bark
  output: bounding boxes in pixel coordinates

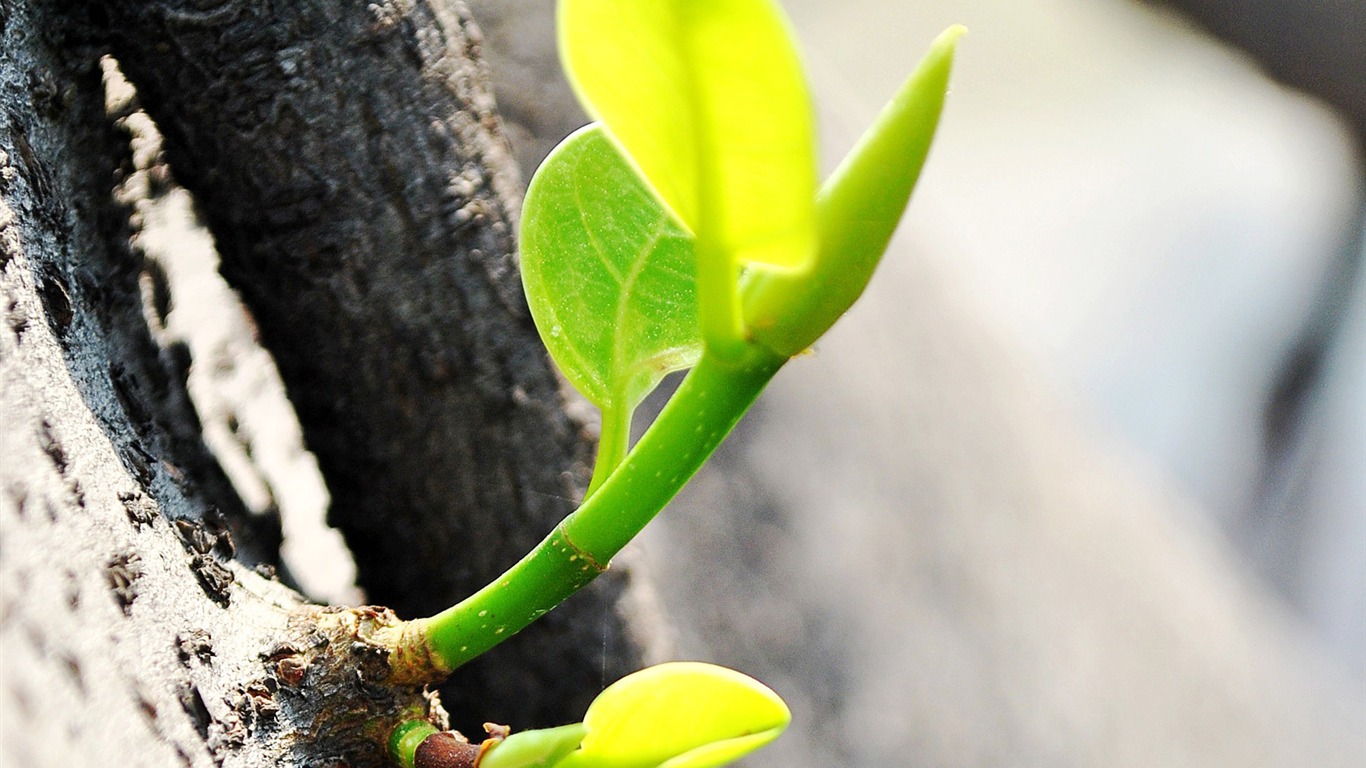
[421,346,787,671]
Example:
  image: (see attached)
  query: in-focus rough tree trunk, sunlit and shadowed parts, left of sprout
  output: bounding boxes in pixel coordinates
[0,1,652,767]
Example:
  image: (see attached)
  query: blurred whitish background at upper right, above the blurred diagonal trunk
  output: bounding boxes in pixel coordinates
[785,0,1366,682]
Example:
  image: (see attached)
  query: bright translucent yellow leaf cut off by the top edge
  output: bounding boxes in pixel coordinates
[559,0,816,269]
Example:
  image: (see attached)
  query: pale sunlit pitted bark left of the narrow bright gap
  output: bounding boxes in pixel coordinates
[0,4,440,768]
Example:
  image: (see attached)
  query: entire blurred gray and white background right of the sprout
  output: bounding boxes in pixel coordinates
[471,0,1366,767]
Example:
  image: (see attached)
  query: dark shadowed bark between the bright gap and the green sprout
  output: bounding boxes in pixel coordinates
[96,1,652,726]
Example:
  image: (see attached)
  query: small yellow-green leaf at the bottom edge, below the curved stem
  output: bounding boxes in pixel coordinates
[559,661,792,768]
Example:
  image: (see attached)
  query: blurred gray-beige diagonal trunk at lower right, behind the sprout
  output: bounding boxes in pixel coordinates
[646,243,1366,767]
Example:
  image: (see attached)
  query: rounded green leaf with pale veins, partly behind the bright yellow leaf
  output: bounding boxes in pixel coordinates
[520,124,701,413]
